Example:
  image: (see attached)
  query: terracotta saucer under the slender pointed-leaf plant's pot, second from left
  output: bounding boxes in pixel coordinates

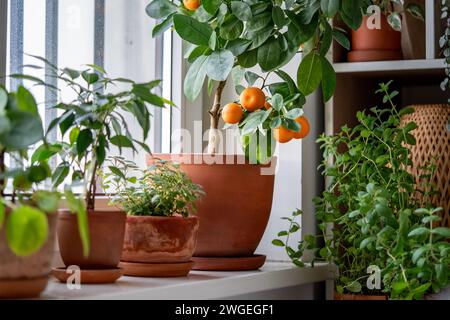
[52,268,123,284]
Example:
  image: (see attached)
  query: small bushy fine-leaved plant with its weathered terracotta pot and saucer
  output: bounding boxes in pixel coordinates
[104,157,203,277]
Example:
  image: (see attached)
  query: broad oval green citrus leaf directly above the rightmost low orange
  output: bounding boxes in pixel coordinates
[297,52,322,96]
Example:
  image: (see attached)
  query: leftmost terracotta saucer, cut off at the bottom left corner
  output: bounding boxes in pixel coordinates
[0,276,48,299]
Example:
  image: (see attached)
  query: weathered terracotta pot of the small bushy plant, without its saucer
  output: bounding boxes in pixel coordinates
[121,216,199,263]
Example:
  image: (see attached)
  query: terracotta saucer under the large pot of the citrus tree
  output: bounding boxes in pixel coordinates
[192,255,266,271]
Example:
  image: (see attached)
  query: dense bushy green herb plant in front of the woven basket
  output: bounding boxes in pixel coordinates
[273,83,450,299]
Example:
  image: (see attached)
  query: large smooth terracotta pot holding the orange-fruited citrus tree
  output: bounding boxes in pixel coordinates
[149,154,276,257]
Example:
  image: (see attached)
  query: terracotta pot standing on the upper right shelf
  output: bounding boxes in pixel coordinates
[348,15,402,62]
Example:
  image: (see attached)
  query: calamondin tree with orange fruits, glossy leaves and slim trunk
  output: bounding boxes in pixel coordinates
[147,0,368,161]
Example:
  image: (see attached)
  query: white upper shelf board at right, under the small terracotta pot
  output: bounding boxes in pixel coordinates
[334,59,444,74]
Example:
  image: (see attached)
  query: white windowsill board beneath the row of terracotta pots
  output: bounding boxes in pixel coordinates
[41,262,334,300]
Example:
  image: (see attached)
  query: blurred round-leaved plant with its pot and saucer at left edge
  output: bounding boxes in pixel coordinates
[0,86,88,298]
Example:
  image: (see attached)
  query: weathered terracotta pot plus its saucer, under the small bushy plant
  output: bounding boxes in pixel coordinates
[120,216,199,277]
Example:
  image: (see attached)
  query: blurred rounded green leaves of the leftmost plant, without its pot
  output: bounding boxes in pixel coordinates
[0,86,89,256]
